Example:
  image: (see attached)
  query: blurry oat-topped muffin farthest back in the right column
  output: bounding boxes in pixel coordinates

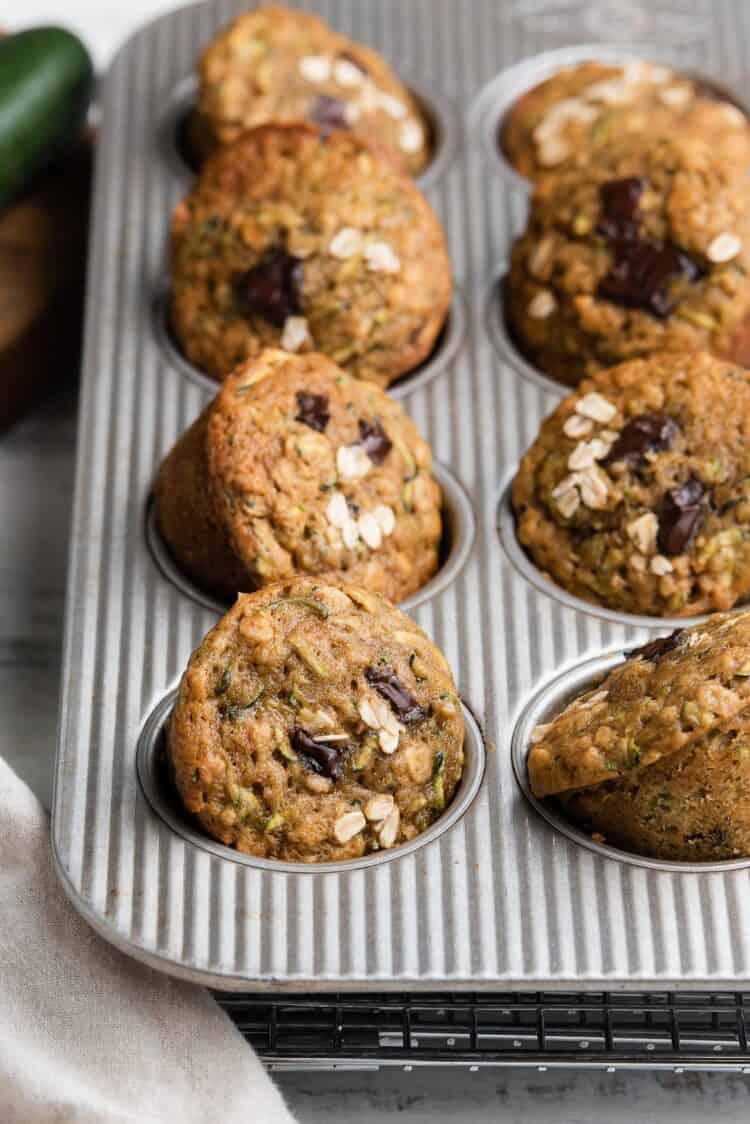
[500,60,750,180]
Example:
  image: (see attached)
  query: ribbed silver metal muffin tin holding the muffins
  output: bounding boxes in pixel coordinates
[53,0,750,995]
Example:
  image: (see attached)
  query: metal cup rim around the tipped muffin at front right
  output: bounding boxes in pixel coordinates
[510,652,750,874]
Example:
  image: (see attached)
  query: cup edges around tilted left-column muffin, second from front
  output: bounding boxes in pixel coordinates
[146,464,475,615]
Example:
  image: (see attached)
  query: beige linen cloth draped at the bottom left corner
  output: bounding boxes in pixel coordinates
[0,759,293,1124]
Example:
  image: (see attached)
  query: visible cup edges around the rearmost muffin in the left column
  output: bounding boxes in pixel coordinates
[156,74,461,191]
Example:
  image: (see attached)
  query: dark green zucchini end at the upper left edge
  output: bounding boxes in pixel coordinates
[0,27,93,206]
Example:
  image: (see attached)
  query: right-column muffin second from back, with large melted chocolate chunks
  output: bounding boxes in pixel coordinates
[505,141,750,386]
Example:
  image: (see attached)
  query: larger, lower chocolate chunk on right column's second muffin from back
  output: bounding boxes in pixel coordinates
[597,239,702,319]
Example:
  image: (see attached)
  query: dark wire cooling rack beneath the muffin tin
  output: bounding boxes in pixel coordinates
[216,991,750,1073]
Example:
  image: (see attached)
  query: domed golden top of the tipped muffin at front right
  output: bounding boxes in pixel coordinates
[528,613,750,797]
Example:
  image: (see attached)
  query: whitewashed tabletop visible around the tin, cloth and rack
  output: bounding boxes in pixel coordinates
[0,0,750,1124]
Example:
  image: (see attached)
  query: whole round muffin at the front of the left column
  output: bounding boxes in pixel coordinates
[168,579,463,862]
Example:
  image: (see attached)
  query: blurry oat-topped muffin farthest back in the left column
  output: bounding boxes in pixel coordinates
[197,7,430,175]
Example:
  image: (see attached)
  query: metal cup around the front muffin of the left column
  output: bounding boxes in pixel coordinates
[136,687,485,874]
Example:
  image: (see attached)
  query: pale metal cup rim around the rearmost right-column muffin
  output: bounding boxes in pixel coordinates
[470,43,750,194]
